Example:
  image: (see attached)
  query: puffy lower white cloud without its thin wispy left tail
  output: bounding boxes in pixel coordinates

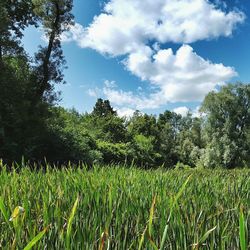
[125,45,237,103]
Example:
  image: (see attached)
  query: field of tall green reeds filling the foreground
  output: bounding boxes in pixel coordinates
[0,163,250,249]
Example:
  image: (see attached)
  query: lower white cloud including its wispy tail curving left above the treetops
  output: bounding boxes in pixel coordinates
[87,45,237,110]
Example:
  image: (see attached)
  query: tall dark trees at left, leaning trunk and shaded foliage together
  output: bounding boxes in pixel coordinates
[0,0,72,161]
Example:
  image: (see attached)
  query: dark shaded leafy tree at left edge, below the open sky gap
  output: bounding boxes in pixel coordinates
[0,55,48,160]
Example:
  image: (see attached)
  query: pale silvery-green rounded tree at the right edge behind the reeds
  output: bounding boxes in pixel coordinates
[202,83,250,168]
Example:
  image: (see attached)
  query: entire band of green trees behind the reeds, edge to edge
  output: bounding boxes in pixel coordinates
[0,0,250,168]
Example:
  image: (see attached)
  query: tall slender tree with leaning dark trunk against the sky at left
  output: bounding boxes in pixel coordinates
[33,0,73,102]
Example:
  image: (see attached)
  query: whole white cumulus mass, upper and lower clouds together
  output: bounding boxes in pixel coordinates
[66,0,245,109]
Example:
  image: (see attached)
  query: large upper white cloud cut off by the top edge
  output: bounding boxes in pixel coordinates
[70,0,245,56]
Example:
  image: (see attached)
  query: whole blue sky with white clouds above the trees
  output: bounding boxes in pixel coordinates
[23,0,250,116]
